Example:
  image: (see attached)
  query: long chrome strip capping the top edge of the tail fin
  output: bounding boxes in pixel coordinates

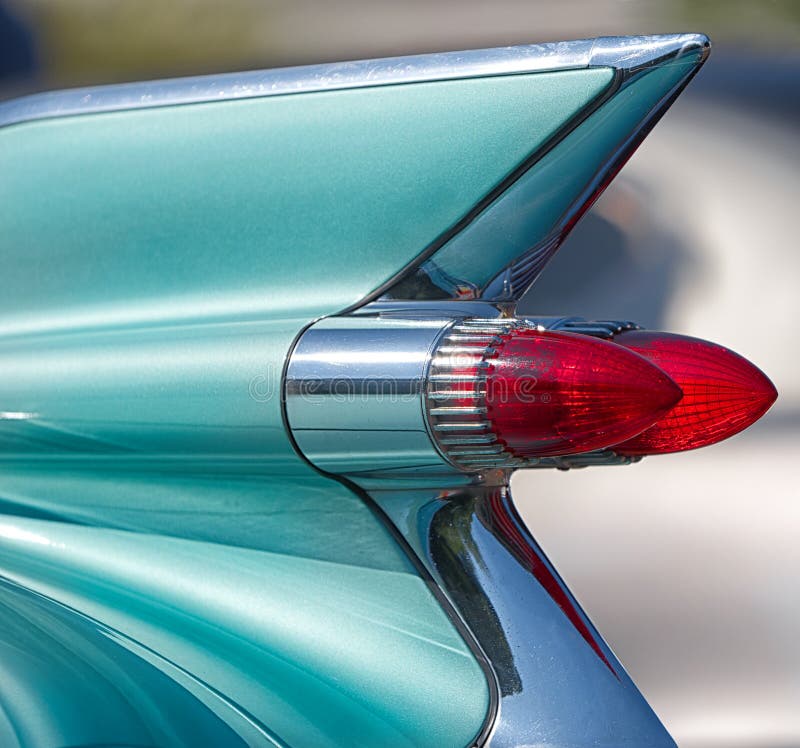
[0,34,699,127]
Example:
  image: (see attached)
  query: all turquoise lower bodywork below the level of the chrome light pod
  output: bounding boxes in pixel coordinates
[0,460,488,748]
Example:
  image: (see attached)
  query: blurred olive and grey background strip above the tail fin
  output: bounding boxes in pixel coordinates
[8,0,800,86]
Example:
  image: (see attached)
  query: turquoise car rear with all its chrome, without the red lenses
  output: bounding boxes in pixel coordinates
[0,34,776,747]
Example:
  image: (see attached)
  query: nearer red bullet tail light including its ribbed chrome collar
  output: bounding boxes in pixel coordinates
[426,320,682,469]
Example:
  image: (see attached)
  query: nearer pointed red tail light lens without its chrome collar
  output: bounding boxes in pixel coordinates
[486,330,681,458]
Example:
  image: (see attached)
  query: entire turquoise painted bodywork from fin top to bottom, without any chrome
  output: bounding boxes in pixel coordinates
[0,70,610,748]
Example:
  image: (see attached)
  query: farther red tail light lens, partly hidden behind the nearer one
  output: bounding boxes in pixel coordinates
[614,330,778,455]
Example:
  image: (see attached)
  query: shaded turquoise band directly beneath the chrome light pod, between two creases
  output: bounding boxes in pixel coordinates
[0,457,413,573]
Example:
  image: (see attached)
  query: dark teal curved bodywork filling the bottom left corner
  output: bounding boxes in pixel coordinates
[0,580,260,748]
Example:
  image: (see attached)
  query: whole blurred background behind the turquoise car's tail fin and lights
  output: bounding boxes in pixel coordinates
[0,0,800,748]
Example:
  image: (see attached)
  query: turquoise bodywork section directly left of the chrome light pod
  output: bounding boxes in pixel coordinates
[0,317,308,458]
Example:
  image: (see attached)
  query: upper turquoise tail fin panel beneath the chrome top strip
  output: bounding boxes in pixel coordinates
[0,69,611,334]
